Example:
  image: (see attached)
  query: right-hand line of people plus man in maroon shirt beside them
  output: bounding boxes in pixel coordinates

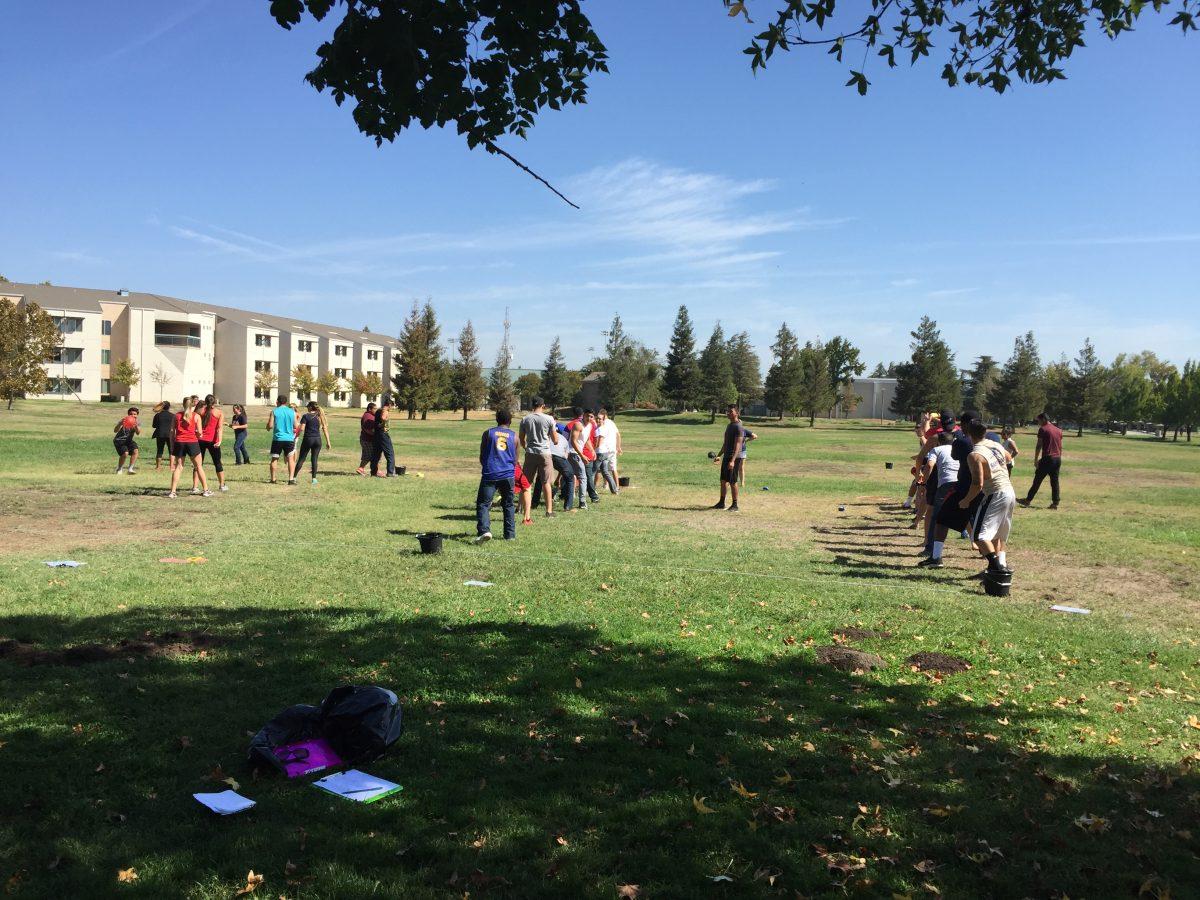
[904,409,1062,577]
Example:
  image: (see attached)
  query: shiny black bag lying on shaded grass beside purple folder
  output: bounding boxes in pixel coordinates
[248,684,403,772]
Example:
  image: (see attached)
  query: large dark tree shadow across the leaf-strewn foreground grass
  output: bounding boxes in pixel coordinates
[0,609,1200,898]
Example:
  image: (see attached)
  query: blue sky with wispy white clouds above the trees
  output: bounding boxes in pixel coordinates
[0,0,1200,367]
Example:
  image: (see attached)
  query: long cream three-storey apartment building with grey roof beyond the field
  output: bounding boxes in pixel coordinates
[0,283,398,407]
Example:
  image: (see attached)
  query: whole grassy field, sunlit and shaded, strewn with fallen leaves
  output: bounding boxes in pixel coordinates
[0,402,1200,899]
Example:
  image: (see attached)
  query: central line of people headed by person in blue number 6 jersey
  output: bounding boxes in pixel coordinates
[475,397,623,542]
